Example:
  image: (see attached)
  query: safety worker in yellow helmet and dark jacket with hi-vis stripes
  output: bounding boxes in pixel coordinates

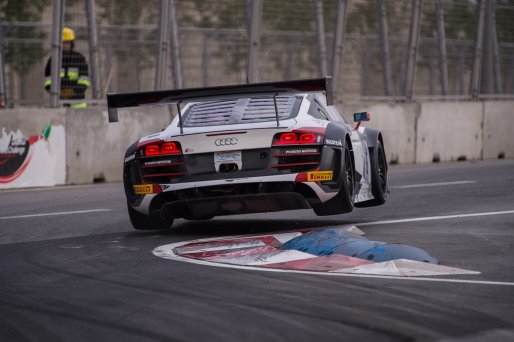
[45,27,90,108]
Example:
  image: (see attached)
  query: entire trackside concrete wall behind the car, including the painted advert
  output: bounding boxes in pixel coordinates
[0,101,514,189]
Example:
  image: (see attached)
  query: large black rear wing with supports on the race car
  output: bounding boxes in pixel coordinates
[107,76,333,124]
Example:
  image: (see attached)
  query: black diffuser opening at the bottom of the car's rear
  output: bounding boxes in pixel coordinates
[161,192,311,219]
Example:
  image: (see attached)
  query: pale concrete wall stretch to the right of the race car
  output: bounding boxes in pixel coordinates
[340,100,514,164]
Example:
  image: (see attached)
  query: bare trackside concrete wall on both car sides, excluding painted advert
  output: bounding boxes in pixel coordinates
[0,101,514,188]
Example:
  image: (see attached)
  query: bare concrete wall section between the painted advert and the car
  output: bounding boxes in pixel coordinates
[66,106,172,184]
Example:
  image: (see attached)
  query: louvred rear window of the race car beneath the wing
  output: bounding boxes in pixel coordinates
[183,95,302,127]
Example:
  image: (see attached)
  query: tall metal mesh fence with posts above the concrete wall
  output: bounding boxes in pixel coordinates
[0,0,514,106]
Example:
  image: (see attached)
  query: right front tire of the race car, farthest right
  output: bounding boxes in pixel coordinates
[355,141,387,208]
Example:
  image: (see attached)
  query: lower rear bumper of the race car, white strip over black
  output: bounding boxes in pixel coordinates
[127,174,337,217]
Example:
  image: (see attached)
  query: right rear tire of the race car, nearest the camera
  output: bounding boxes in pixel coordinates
[312,145,355,216]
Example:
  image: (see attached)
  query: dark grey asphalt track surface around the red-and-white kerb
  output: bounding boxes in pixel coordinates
[0,160,514,341]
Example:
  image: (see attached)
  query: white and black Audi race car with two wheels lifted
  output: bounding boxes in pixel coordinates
[107,77,388,229]
